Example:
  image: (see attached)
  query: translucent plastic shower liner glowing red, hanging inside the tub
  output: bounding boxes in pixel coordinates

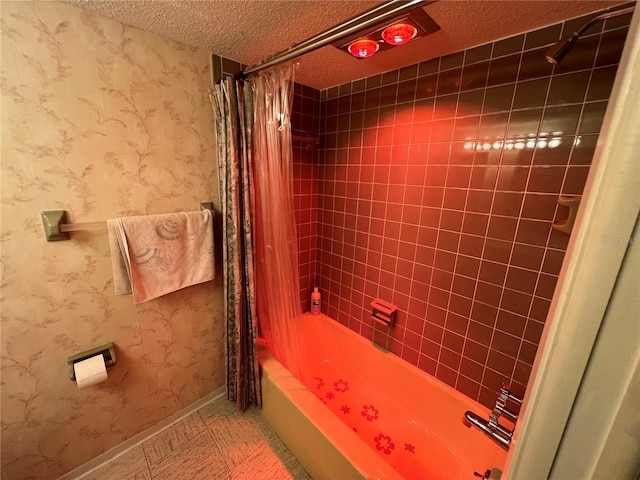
[251,63,309,385]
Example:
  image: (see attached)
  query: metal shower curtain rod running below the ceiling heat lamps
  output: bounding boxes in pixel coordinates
[242,0,436,75]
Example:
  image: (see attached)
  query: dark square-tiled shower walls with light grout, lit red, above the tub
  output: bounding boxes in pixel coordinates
[308,11,629,406]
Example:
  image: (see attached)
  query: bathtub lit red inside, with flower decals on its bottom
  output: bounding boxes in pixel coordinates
[258,313,506,480]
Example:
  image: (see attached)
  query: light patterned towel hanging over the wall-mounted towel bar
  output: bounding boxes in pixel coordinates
[107,210,215,304]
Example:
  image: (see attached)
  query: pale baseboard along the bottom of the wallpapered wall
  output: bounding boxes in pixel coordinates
[58,386,226,480]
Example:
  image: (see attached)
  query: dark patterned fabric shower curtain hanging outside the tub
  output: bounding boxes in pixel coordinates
[211,77,262,410]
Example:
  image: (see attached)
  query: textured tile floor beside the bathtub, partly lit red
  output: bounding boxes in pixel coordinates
[81,397,311,480]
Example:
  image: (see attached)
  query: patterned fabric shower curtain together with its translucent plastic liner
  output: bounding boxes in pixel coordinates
[212,64,309,409]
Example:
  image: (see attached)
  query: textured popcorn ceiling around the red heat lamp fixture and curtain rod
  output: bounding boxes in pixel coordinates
[65,0,621,89]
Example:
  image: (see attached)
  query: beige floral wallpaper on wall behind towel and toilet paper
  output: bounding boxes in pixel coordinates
[0,2,224,480]
